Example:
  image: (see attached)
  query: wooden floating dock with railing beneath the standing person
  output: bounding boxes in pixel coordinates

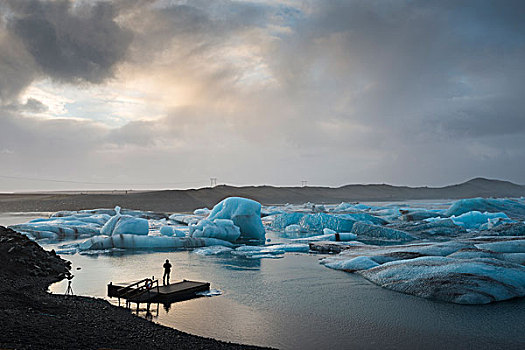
[108,278,210,304]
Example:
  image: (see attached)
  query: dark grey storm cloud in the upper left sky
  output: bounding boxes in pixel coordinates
[7,0,132,83]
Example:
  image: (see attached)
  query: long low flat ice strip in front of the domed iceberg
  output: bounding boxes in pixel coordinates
[79,234,233,251]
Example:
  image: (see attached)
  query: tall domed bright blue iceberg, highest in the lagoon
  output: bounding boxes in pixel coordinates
[208,197,265,241]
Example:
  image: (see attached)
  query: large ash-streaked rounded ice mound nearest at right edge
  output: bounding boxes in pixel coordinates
[358,257,525,304]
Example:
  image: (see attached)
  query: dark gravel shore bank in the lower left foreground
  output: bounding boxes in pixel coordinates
[0,226,268,350]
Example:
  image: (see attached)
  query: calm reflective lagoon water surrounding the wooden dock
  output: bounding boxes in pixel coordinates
[0,212,525,349]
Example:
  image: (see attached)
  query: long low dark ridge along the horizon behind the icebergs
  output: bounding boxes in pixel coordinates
[0,178,525,212]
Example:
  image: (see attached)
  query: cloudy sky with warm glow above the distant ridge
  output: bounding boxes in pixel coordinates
[0,0,525,192]
